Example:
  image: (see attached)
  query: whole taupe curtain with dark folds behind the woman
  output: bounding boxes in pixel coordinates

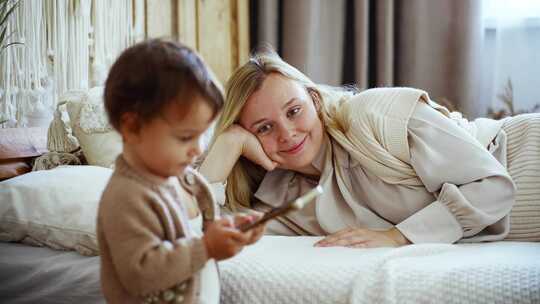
[251,0,489,117]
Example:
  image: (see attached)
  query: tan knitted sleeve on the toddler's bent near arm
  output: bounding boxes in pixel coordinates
[98,189,208,295]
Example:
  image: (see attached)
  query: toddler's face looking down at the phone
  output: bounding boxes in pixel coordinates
[132,94,214,177]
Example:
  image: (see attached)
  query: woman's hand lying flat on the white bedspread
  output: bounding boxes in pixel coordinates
[315,227,411,248]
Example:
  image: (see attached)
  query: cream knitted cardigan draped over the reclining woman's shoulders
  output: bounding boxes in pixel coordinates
[328,88,504,185]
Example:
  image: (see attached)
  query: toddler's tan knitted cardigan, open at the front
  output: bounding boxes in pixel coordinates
[97,156,217,303]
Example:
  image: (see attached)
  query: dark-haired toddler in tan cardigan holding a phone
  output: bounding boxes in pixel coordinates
[97,39,264,303]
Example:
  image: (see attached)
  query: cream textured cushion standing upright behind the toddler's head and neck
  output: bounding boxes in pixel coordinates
[62,87,122,168]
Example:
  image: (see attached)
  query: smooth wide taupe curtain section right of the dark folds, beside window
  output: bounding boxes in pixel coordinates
[395,0,490,117]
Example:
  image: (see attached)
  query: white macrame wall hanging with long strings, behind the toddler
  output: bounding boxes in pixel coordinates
[0,0,145,127]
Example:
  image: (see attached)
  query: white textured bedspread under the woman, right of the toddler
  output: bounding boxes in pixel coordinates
[220,236,540,304]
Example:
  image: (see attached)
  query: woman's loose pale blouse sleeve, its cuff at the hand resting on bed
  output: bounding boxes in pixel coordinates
[396,103,515,243]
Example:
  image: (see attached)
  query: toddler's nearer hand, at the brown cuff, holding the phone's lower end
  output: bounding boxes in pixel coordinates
[203,218,250,261]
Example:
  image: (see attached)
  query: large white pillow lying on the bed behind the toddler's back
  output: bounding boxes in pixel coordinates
[0,166,112,255]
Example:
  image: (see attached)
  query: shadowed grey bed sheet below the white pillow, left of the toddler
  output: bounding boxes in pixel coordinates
[0,243,105,304]
